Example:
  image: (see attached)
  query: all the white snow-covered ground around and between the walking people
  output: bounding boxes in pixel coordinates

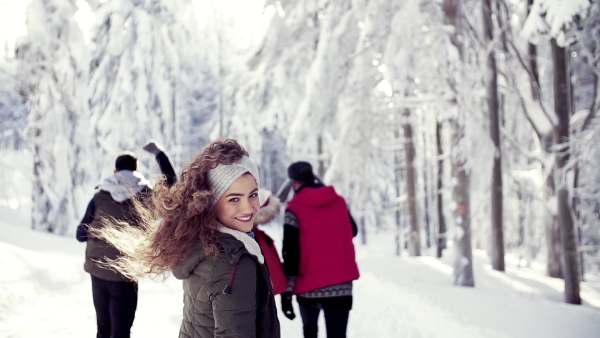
[0,205,600,338]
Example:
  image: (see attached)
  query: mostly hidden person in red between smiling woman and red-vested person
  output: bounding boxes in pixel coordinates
[252,189,287,295]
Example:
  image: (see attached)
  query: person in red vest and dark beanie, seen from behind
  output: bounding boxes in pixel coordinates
[281,162,359,338]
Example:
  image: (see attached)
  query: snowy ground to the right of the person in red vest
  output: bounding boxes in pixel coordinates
[349,252,600,338]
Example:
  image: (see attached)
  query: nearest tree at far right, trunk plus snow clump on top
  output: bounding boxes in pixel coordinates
[523,0,590,304]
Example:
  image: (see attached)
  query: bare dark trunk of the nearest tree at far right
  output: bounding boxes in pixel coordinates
[551,39,581,304]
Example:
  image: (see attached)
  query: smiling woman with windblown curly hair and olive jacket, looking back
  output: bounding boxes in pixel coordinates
[86,139,280,338]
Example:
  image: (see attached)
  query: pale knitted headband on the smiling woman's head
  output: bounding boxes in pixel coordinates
[208,156,260,205]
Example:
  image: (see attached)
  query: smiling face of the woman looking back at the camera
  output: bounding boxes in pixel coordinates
[215,173,260,232]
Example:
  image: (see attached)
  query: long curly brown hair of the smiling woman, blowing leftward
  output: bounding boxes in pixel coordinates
[92,139,248,280]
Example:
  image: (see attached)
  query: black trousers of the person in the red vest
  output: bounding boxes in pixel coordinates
[296,296,352,338]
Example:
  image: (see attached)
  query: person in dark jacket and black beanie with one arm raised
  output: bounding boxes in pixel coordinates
[76,141,175,338]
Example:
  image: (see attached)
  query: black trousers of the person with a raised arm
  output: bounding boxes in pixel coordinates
[92,276,138,338]
